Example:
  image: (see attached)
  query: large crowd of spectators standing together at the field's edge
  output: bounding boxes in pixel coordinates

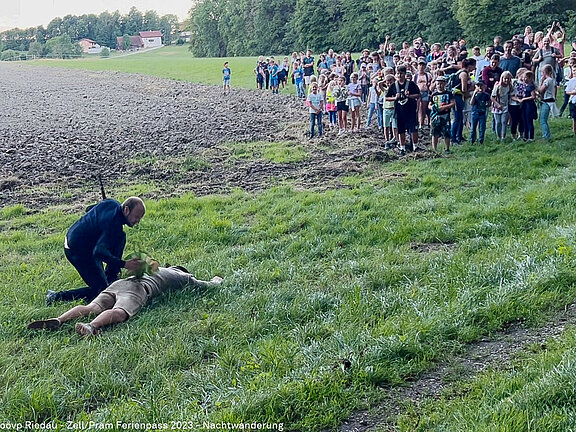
[254,22,576,153]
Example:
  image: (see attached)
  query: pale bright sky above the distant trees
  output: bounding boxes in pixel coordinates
[0,0,193,31]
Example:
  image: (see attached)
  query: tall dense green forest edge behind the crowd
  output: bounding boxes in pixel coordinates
[190,0,576,57]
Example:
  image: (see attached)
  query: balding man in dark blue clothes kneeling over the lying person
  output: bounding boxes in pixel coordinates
[46,197,146,304]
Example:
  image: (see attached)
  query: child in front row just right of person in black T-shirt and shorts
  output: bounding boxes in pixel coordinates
[429,76,456,154]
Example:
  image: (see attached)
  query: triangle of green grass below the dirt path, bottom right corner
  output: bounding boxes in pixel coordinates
[400,328,576,432]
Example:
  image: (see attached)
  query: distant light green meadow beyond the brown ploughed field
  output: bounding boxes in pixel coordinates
[26,45,294,92]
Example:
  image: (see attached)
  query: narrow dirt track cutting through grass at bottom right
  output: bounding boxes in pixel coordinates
[338,304,576,432]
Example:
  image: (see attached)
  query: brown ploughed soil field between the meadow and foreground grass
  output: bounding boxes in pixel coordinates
[0,62,435,208]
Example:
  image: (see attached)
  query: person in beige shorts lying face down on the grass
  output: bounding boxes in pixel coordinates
[28,266,222,336]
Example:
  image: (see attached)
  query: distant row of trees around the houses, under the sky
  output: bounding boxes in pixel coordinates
[0,7,179,56]
